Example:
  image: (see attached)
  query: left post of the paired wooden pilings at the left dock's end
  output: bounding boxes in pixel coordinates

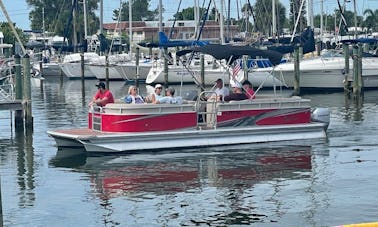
[14,54,24,129]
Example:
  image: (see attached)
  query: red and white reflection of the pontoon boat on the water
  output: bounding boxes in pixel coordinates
[51,144,312,226]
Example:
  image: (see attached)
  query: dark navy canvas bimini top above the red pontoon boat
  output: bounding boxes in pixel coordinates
[176,44,282,65]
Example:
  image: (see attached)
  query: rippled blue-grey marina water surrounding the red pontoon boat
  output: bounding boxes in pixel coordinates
[0,77,378,227]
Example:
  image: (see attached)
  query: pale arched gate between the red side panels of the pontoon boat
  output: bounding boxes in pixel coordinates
[196,91,218,130]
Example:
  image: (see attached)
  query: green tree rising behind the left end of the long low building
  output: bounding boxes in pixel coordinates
[113,0,159,21]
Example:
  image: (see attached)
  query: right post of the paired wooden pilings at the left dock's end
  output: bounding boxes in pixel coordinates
[23,54,33,131]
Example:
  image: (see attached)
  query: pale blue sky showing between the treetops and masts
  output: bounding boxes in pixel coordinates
[0,0,378,30]
